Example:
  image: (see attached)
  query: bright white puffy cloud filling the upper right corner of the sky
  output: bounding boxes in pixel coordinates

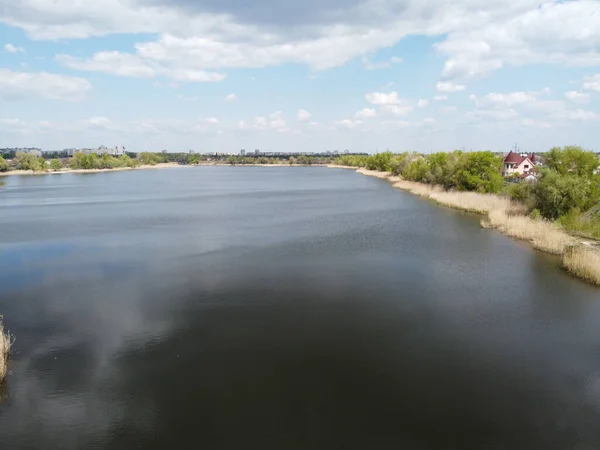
[437,0,600,80]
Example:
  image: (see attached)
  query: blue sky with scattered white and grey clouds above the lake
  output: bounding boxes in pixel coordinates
[0,0,600,153]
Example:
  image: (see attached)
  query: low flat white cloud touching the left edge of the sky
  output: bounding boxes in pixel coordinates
[0,68,92,101]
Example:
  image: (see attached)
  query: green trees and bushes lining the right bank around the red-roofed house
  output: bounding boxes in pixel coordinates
[338,146,600,238]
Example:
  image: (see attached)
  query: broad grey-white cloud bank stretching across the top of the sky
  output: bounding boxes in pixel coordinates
[0,0,600,84]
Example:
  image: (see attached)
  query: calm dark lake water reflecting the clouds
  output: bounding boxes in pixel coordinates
[0,167,600,450]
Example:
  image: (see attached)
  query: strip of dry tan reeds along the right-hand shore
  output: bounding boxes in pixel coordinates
[357,169,600,285]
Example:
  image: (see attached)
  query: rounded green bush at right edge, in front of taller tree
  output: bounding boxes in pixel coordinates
[534,169,600,219]
